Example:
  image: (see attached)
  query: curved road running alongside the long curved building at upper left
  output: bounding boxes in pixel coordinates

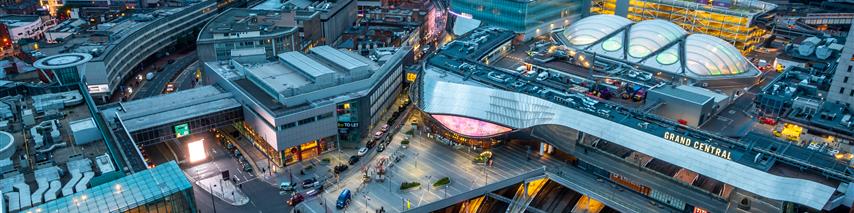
[131,51,198,100]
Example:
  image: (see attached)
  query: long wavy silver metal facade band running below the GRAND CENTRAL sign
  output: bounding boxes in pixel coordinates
[419,75,835,209]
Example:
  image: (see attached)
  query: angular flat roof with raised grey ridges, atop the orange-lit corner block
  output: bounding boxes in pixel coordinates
[205,46,408,114]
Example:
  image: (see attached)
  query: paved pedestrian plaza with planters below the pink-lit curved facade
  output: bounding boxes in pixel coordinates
[299,118,562,212]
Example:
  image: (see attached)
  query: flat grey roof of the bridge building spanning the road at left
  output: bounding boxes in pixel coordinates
[102,86,241,132]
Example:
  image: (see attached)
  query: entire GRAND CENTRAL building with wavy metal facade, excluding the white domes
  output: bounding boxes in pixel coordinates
[410,25,854,212]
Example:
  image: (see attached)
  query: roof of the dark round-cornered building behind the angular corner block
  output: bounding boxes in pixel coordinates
[199,8,297,40]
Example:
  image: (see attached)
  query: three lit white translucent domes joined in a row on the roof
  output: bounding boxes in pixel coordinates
[555,15,761,87]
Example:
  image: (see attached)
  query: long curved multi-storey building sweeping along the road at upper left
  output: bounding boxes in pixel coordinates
[32,1,240,103]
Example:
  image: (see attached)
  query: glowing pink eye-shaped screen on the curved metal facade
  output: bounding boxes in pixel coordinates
[433,115,511,137]
